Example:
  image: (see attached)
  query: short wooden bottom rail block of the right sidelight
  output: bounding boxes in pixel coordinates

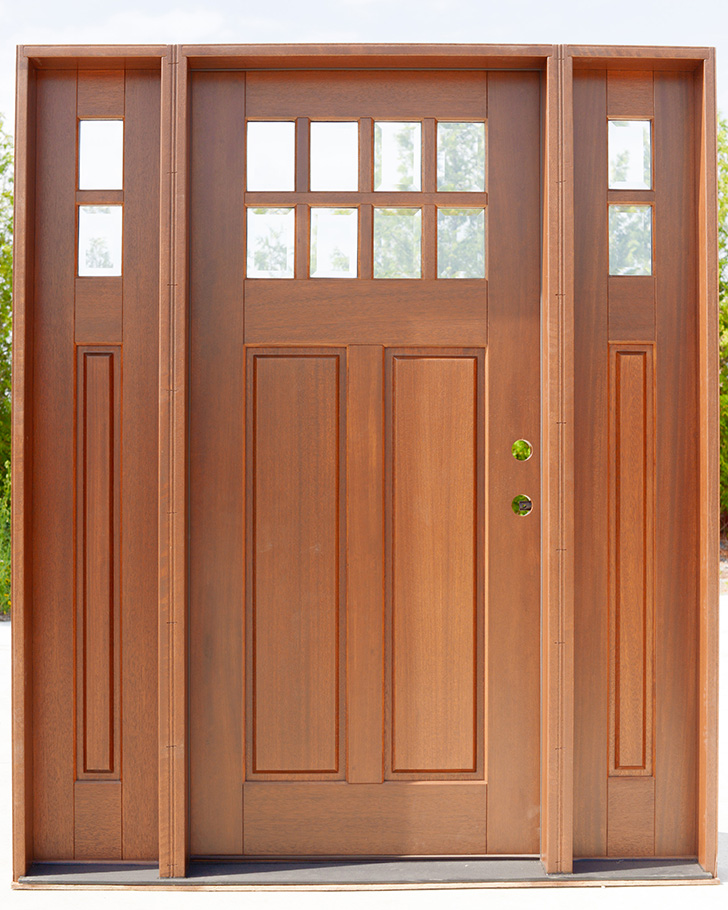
[607,777,655,858]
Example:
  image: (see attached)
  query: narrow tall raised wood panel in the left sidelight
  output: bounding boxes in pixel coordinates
[76,348,121,777]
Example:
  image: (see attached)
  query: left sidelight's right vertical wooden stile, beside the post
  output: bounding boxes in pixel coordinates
[121,70,160,860]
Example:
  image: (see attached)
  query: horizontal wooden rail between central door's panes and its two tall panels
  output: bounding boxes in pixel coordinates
[245,278,487,345]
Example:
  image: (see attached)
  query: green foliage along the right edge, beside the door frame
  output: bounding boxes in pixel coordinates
[718,117,728,532]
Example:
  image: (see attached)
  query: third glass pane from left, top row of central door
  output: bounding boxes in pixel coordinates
[374,120,422,193]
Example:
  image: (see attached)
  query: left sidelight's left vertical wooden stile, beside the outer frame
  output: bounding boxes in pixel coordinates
[32,71,76,860]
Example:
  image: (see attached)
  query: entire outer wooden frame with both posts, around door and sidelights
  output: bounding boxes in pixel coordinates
[12,44,719,881]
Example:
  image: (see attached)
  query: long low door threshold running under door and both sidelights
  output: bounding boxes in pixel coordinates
[14,857,718,891]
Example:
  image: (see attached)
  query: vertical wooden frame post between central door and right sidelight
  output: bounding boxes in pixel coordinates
[541,46,574,873]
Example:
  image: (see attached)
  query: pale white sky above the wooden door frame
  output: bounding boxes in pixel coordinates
[0,0,728,131]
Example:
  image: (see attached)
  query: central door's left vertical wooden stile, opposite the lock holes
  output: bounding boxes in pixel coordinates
[190,73,245,854]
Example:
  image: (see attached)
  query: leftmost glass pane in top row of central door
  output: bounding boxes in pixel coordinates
[246,120,296,192]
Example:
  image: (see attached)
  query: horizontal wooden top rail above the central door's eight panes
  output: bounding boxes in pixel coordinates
[246,70,487,120]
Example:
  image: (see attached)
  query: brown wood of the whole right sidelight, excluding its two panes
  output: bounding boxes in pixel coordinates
[575,62,699,856]
